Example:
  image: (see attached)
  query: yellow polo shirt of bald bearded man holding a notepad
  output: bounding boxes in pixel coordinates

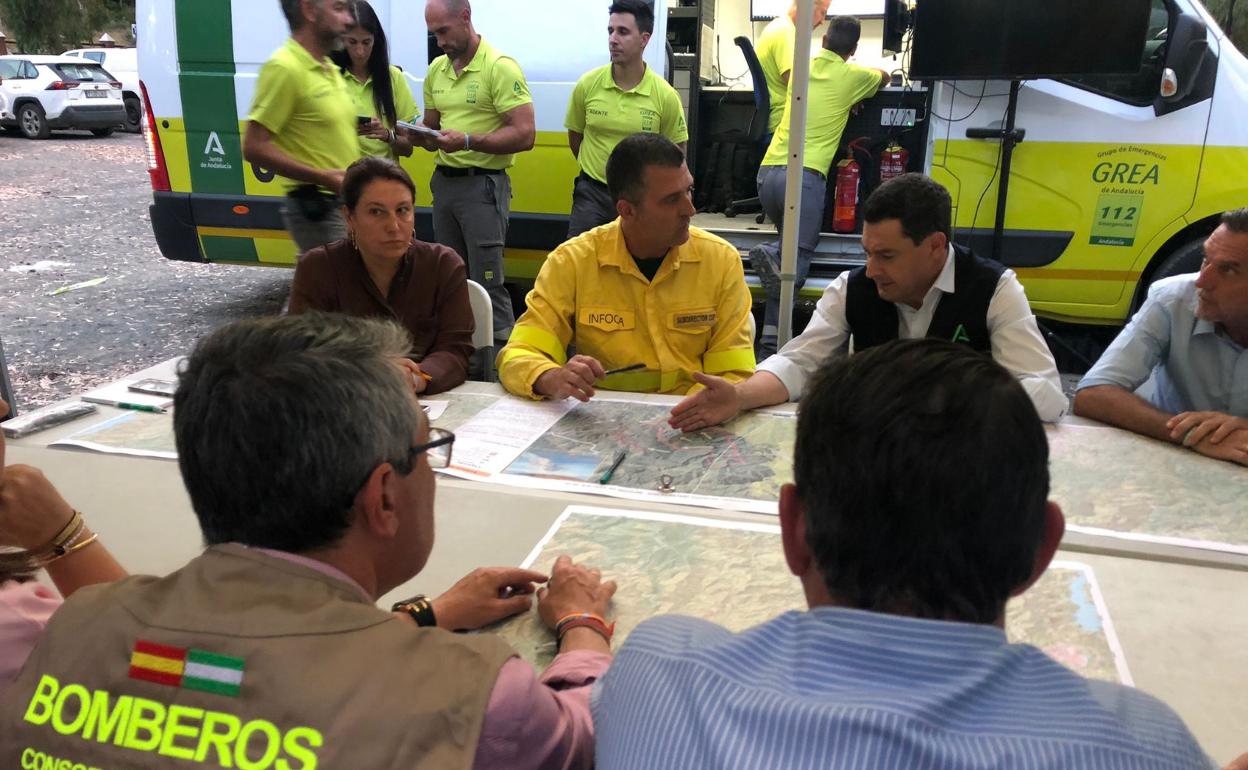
[424,37,533,168]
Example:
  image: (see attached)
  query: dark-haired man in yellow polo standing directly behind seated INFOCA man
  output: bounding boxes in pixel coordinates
[563,0,689,238]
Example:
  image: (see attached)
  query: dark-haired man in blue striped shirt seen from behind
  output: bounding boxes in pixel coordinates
[594,339,1212,770]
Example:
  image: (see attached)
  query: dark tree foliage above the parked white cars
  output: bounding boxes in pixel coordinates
[0,0,135,54]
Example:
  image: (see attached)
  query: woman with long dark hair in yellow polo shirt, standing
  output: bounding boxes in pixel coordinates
[329,0,419,161]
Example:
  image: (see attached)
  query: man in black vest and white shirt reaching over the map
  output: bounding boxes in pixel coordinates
[669,173,1067,432]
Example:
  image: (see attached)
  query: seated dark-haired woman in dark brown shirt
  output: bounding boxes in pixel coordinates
[291,157,473,394]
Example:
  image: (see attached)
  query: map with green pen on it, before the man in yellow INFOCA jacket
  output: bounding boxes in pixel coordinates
[434,393,796,513]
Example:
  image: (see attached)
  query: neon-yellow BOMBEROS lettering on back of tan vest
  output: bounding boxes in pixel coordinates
[22,674,324,770]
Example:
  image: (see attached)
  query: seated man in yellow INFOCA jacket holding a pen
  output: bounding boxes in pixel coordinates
[498,134,754,401]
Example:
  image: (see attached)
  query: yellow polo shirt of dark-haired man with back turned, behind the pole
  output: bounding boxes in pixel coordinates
[763,49,881,173]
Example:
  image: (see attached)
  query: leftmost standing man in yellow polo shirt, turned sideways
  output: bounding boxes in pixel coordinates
[242,0,359,253]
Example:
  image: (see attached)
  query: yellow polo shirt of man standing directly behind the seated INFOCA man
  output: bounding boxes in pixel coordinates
[563,65,689,185]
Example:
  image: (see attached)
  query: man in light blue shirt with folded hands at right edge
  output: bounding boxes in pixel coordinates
[1075,208,1248,465]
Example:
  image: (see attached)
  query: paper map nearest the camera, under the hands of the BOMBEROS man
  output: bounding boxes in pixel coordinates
[497,505,1131,684]
